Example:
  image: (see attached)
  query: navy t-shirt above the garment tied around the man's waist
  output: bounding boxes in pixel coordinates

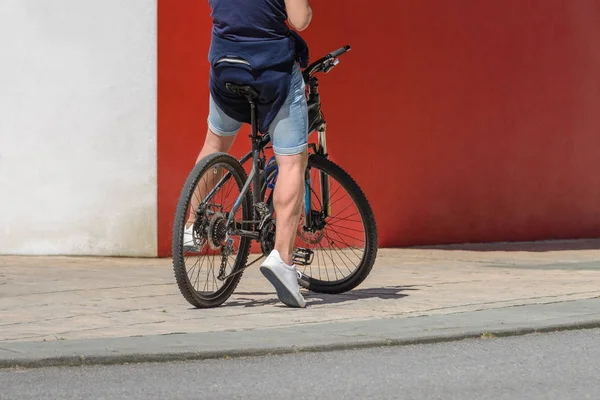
[208,0,289,41]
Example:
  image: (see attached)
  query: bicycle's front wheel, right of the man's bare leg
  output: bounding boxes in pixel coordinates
[268,154,378,294]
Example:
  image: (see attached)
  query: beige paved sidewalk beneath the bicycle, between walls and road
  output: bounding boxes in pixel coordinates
[0,240,600,366]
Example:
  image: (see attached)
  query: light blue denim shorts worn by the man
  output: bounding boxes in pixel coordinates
[208,64,308,156]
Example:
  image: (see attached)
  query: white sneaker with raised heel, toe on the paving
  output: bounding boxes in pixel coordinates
[260,250,306,308]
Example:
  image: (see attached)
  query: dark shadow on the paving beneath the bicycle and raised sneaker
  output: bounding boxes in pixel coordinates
[222,285,419,308]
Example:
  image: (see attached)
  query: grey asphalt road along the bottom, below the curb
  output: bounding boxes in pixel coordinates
[0,330,600,400]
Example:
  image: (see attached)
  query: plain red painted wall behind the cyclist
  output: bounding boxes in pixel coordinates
[158,0,600,255]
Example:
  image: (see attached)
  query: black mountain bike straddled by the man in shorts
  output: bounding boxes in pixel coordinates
[172,46,377,308]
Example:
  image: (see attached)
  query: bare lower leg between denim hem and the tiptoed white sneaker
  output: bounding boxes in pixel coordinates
[273,151,307,265]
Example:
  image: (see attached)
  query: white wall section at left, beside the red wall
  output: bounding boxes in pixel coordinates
[0,0,157,256]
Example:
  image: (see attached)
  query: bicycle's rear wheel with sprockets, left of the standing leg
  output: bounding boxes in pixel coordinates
[172,153,252,308]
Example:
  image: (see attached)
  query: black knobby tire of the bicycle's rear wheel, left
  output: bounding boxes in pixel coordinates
[172,153,252,308]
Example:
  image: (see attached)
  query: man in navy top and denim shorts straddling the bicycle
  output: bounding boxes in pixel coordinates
[186,0,312,307]
